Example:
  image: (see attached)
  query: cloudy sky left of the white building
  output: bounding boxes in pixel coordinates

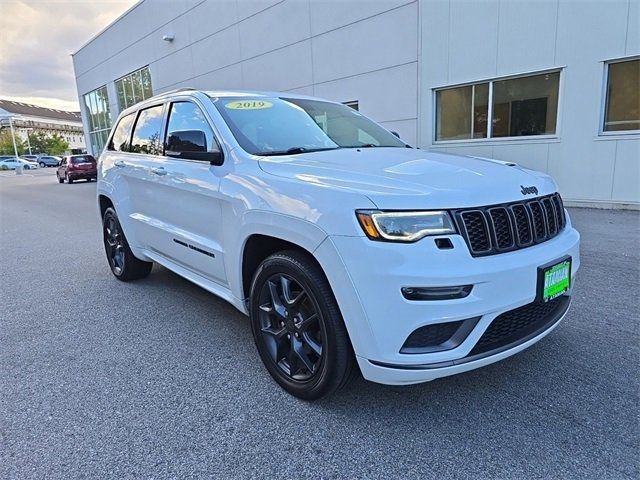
[0,0,136,110]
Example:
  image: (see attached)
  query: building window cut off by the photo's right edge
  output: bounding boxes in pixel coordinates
[602,59,640,132]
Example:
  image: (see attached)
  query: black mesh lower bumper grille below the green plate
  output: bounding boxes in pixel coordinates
[469,296,570,356]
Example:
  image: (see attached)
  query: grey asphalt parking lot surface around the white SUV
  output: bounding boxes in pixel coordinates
[0,168,640,479]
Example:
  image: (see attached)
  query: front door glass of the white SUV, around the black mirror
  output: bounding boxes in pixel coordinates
[167,102,217,152]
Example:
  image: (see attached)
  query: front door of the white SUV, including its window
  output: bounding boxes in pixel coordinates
[143,97,227,286]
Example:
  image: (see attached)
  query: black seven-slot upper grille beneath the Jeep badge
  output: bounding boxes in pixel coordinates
[454,193,566,257]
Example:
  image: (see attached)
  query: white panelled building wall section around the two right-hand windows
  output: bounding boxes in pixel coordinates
[419,0,640,205]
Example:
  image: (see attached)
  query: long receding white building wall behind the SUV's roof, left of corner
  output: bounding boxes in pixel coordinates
[73,0,418,143]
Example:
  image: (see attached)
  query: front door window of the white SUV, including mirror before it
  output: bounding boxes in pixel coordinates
[165,102,219,159]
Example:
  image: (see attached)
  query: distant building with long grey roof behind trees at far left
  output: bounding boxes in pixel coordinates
[0,99,86,153]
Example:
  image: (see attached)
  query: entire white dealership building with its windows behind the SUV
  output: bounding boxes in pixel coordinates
[73,0,640,208]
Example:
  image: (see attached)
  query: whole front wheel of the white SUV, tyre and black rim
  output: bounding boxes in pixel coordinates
[250,251,354,400]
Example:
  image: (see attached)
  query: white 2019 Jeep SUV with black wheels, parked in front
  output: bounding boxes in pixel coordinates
[98,89,580,399]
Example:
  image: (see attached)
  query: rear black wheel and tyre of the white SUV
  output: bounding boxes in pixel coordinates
[102,208,153,282]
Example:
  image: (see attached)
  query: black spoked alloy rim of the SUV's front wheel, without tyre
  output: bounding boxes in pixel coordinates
[259,273,326,381]
